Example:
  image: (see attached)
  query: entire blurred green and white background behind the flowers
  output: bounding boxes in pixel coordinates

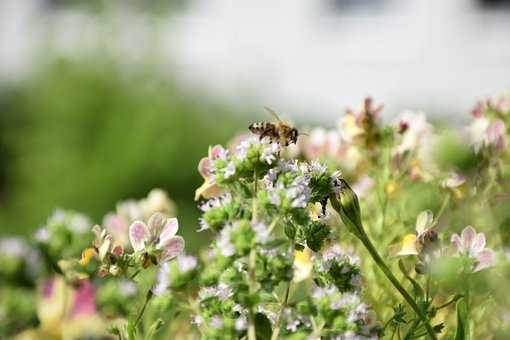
[0,0,510,247]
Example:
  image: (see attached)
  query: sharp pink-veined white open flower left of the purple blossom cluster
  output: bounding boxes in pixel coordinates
[129,213,184,261]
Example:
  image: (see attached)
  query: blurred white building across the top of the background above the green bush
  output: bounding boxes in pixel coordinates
[0,0,510,119]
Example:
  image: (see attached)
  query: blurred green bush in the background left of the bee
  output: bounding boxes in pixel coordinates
[0,59,242,250]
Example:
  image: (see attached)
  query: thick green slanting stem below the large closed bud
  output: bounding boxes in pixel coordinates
[359,229,437,340]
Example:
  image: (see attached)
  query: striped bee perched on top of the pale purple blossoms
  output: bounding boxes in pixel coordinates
[248,107,299,146]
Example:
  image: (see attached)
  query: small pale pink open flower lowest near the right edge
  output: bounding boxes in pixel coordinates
[451,226,495,272]
